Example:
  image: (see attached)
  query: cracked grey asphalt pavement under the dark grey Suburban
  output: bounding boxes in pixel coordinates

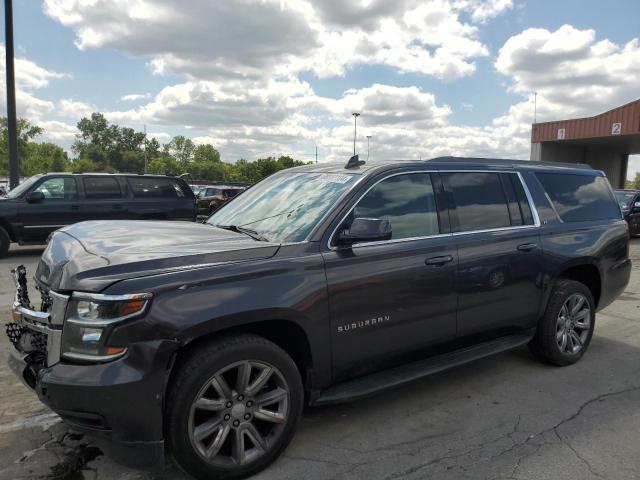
[0,244,640,480]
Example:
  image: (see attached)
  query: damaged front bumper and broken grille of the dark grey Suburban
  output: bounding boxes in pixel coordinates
[6,266,176,470]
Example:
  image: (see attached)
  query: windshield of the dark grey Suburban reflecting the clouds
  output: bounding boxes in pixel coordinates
[207,173,358,243]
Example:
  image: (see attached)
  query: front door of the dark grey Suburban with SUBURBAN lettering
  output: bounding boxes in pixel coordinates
[323,172,457,379]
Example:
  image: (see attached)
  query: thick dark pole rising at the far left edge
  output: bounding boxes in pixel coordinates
[4,0,20,189]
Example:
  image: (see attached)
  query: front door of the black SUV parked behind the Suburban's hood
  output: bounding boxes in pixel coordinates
[18,176,80,242]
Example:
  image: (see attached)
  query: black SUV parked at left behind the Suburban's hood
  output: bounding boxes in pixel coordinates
[0,173,195,257]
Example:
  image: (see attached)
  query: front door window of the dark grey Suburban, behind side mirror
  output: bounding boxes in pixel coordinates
[353,173,440,239]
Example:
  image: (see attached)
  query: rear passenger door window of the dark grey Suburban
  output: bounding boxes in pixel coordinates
[446,172,511,232]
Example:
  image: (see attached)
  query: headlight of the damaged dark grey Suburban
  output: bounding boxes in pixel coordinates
[61,292,151,362]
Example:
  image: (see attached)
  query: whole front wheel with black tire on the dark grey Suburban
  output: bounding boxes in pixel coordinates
[165,335,304,480]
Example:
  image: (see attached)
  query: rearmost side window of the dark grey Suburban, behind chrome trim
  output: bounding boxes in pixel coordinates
[536,173,620,222]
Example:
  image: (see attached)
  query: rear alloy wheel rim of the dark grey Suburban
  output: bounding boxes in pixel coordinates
[556,293,591,355]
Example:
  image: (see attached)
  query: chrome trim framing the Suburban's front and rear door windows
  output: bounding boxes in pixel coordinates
[327,169,541,251]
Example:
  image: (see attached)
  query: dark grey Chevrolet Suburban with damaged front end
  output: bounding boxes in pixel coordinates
[9,158,631,479]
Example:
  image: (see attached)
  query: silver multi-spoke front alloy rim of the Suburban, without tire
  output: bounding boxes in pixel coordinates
[189,360,290,467]
